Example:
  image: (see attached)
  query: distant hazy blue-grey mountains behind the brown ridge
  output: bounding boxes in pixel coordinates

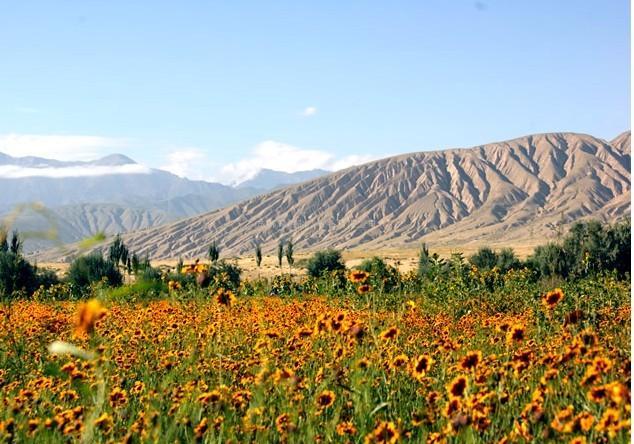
[0,153,323,251]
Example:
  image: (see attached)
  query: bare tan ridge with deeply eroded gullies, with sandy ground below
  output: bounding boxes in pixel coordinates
[35,131,631,259]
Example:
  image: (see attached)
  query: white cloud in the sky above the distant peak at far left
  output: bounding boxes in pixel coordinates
[0,134,127,160]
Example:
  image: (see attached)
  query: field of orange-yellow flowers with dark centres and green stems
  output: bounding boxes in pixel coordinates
[0,280,631,443]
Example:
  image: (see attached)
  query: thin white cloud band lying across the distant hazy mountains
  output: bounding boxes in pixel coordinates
[0,163,150,179]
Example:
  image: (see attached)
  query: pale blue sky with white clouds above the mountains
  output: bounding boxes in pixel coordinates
[0,0,630,182]
